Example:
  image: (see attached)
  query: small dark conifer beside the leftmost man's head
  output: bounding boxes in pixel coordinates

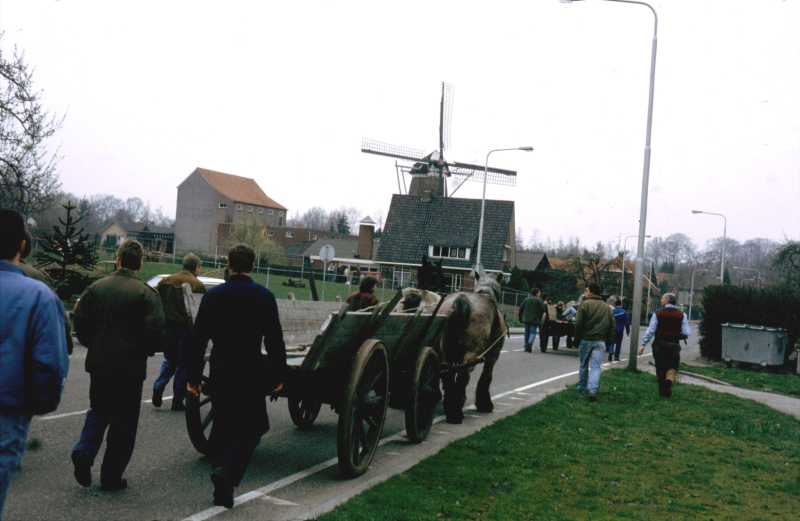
[35,201,98,297]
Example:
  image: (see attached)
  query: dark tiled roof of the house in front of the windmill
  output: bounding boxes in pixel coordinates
[375,194,514,270]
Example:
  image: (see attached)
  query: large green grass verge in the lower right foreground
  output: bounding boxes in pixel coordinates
[319,370,800,521]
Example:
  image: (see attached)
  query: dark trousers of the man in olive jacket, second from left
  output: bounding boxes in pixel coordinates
[73,374,144,483]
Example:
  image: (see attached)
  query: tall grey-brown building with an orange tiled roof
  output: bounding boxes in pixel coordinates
[175,168,288,253]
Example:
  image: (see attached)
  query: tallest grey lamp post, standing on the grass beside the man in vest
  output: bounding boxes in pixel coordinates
[561,0,658,370]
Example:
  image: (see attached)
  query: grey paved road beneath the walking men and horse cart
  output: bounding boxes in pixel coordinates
[4,330,648,521]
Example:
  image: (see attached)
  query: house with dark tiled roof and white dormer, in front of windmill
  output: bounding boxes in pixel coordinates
[375,191,516,291]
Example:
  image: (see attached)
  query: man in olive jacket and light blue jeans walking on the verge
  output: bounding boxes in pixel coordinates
[575,282,615,402]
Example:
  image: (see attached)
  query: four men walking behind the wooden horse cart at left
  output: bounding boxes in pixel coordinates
[0,209,286,517]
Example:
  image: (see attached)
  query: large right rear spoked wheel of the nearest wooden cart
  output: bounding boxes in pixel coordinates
[336,339,389,477]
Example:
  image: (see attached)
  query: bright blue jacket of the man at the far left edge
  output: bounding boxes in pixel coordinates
[0,261,69,414]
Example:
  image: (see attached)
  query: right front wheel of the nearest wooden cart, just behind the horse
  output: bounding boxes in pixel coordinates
[406,347,442,443]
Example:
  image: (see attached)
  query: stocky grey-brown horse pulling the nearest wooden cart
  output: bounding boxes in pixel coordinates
[439,267,506,424]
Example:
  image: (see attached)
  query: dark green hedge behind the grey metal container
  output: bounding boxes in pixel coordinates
[700,284,800,363]
